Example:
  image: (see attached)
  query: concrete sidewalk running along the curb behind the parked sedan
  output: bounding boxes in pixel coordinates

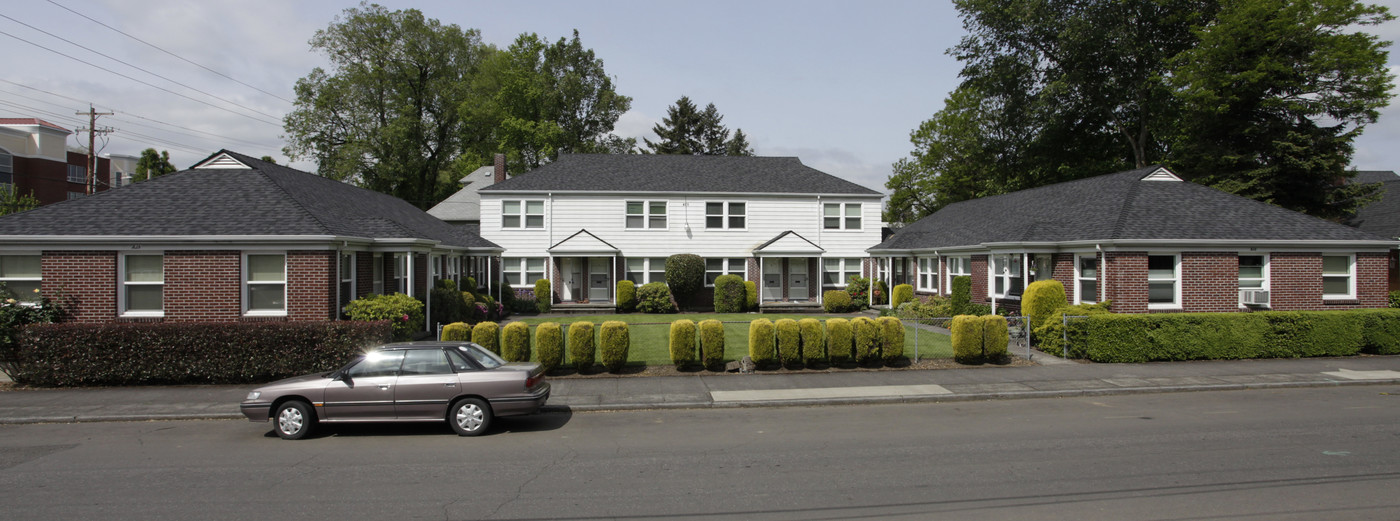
[0,354,1400,424]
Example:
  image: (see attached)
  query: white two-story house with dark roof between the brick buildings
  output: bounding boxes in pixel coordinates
[480,154,881,307]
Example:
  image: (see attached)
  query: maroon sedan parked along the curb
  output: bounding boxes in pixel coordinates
[239,342,549,440]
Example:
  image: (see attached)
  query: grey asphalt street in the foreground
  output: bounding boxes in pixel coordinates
[0,385,1400,520]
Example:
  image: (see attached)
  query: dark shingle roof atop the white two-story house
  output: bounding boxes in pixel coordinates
[482,154,881,196]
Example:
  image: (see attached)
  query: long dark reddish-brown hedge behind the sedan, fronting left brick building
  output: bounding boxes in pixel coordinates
[10,321,392,387]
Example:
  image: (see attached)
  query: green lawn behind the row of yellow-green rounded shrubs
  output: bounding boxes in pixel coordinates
[504,314,953,366]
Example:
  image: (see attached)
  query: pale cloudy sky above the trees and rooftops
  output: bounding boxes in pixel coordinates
[0,0,1400,190]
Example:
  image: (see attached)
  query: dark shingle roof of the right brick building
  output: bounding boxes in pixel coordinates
[871,167,1386,251]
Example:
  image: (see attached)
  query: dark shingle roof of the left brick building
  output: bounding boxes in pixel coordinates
[0,150,498,248]
